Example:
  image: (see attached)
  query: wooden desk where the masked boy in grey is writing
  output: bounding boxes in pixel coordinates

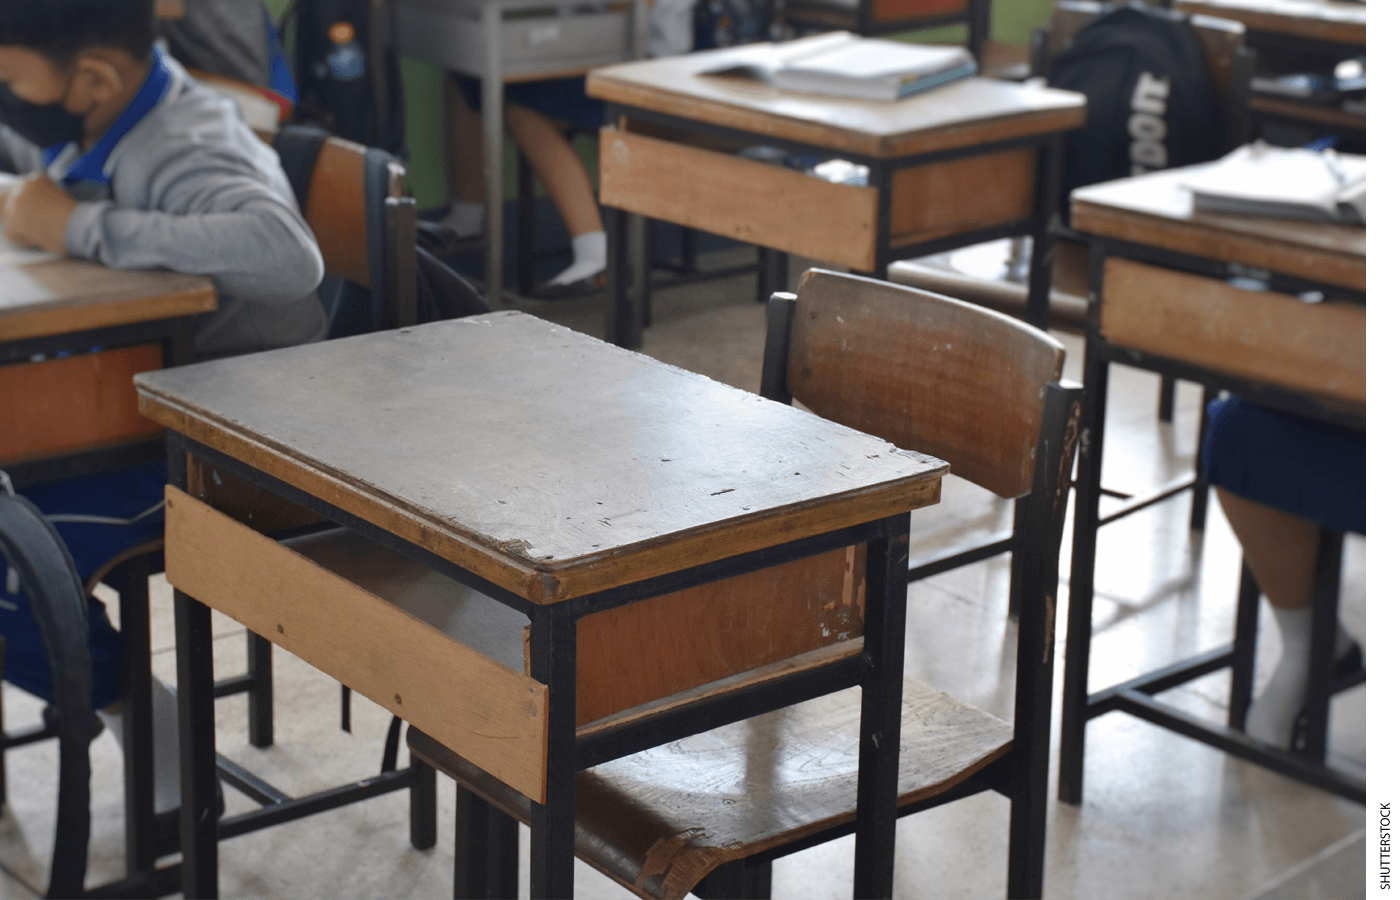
[0,249,217,885]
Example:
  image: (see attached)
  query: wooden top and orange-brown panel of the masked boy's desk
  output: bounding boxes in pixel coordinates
[0,259,217,466]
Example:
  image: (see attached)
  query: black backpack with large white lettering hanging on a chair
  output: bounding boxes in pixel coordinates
[1047,7,1229,223]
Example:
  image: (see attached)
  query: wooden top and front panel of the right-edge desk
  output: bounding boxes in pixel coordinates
[1071,163,1366,409]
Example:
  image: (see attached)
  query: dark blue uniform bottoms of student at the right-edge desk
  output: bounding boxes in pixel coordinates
[1203,398,1366,535]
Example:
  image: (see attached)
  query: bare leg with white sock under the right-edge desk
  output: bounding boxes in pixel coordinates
[1215,487,1351,747]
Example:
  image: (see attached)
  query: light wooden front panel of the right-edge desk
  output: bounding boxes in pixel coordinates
[1099,258,1366,407]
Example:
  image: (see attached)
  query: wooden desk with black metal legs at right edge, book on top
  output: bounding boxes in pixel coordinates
[1060,168,1366,803]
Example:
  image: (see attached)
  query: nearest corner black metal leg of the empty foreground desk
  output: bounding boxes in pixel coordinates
[529,602,578,900]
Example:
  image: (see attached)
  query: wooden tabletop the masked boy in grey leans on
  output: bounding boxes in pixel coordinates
[0,259,218,348]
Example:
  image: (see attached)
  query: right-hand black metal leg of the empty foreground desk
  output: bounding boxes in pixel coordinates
[855,512,909,899]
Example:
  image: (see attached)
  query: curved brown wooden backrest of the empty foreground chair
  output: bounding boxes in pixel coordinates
[763,269,1064,497]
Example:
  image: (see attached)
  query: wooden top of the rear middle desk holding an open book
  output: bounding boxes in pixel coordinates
[588,41,1085,158]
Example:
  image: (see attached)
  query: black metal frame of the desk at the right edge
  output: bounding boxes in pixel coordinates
[1060,235,1366,805]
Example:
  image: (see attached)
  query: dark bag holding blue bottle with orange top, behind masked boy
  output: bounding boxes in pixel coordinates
[283,0,407,158]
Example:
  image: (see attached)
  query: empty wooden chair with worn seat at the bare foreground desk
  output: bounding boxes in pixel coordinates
[409,270,1079,899]
